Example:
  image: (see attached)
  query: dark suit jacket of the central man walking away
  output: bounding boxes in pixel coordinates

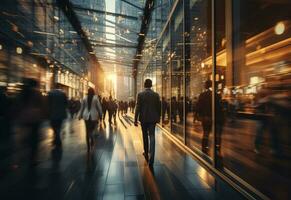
[134,88,161,123]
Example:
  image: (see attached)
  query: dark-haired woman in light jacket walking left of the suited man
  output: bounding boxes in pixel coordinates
[79,88,102,152]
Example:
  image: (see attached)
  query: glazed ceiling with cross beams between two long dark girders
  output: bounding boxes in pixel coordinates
[70,0,145,75]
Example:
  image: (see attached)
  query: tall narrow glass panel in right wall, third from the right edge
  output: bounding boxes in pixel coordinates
[170,1,184,141]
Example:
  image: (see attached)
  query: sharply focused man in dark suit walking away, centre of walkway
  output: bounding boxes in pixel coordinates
[134,79,161,168]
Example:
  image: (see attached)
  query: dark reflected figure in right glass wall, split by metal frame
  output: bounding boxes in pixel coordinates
[196,80,224,154]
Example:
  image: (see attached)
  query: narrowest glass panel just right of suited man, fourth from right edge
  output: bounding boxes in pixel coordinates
[161,28,171,130]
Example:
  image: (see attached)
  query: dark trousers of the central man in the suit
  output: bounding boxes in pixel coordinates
[141,123,156,165]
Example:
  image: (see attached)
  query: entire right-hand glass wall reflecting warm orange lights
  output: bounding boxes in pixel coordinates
[138,0,291,199]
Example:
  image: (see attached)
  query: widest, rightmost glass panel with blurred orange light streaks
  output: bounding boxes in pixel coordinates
[216,0,291,199]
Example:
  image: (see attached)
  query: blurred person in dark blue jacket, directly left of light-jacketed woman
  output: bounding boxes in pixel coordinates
[48,85,68,147]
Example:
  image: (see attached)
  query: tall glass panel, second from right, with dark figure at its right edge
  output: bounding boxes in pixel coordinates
[184,0,213,158]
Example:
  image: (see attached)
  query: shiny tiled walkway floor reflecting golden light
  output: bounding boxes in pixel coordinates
[0,117,243,200]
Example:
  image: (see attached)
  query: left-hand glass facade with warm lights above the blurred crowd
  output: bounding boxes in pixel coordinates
[0,0,102,98]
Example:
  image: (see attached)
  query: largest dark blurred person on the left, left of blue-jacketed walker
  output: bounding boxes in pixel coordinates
[17,78,46,165]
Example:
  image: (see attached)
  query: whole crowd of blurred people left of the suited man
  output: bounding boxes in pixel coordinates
[0,78,135,164]
